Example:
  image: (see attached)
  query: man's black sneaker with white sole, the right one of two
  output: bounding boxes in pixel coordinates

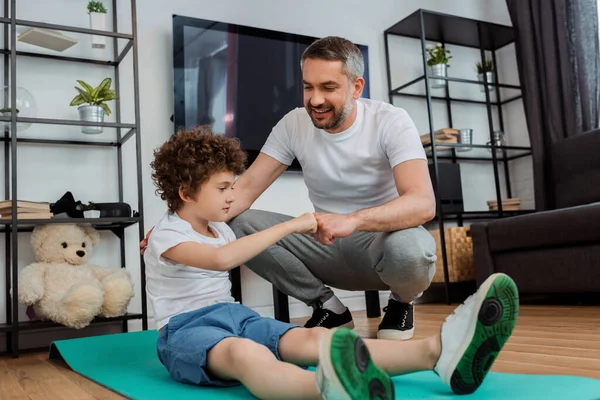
[377,299,415,340]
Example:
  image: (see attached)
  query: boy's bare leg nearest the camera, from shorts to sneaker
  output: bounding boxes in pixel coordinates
[208,338,321,399]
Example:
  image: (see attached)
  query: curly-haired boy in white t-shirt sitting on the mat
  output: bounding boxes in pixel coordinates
[144,127,518,399]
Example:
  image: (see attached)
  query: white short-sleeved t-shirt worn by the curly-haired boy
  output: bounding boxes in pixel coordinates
[144,211,236,329]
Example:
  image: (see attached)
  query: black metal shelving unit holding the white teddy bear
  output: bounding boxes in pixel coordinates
[0,0,148,357]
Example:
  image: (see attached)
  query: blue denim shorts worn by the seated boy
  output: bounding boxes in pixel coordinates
[156,303,298,386]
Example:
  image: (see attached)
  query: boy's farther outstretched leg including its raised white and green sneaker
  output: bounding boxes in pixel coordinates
[279,273,519,394]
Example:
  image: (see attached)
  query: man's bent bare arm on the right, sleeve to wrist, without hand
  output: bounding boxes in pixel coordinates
[350,160,435,232]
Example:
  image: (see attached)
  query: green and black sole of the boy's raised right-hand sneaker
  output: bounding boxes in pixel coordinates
[449,273,519,394]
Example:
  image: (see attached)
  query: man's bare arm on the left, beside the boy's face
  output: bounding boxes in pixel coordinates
[228,153,288,220]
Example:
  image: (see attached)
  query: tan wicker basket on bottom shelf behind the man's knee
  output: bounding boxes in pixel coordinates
[429,227,475,282]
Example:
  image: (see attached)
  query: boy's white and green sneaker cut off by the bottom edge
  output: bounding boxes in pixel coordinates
[317,328,394,400]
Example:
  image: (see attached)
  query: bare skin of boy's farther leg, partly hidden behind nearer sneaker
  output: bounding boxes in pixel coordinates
[279,328,440,376]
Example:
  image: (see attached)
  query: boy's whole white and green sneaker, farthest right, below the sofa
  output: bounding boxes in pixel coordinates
[434,273,519,394]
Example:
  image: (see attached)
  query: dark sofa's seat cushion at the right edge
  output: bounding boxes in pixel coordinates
[488,202,600,252]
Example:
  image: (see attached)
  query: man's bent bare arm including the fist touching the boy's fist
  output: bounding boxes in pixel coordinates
[314,159,436,245]
